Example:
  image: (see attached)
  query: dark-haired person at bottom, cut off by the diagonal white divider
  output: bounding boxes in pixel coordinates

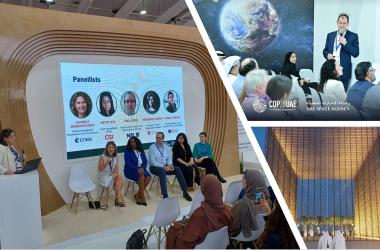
[256,199,299,249]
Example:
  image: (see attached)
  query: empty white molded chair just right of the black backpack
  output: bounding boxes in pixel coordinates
[142,196,180,249]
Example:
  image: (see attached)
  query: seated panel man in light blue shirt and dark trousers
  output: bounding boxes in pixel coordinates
[149,132,192,201]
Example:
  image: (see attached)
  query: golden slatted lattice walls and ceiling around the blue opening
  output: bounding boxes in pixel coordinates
[266,128,380,239]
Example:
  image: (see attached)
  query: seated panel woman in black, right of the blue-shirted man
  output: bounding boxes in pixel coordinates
[172,133,200,191]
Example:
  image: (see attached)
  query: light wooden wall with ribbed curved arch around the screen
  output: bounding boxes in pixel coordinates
[0,4,239,215]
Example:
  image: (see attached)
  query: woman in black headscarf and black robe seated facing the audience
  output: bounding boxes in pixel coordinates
[281,51,316,94]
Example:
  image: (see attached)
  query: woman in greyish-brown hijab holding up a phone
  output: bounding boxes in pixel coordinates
[229,170,270,238]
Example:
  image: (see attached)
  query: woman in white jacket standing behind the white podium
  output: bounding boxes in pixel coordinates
[0,128,26,175]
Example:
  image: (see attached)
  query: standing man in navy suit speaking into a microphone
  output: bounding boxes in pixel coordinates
[323,14,359,92]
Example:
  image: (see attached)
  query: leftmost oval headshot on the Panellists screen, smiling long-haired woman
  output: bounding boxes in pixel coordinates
[70,91,92,118]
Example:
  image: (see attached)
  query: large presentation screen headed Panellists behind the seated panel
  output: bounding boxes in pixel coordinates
[60,62,185,159]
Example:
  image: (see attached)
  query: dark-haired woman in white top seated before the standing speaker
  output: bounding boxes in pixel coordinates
[318,59,347,102]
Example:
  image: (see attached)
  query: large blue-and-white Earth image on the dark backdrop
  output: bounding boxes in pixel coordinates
[219,0,280,52]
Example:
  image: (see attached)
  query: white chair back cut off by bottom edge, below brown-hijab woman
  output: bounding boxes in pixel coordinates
[195,226,230,249]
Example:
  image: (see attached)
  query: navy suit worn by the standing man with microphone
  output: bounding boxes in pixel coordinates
[323,30,359,85]
